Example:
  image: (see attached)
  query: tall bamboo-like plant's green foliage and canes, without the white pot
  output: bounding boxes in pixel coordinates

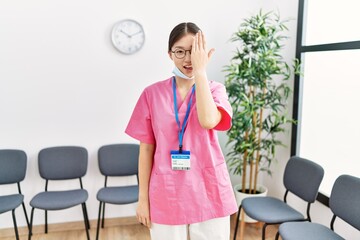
[224,10,300,217]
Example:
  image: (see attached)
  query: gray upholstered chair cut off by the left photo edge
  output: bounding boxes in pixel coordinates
[0,149,29,240]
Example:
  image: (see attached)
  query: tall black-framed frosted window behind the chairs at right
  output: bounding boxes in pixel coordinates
[291,0,360,203]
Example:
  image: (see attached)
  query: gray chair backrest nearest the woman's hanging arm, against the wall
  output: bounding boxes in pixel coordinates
[98,143,139,176]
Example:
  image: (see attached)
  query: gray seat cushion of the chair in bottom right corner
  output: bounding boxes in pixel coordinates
[279,222,344,240]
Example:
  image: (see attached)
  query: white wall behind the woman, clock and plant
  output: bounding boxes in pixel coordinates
[0,0,297,231]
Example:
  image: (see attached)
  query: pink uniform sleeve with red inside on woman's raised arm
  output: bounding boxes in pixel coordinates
[212,83,232,131]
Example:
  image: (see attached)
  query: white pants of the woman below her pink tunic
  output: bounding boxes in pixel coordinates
[150,216,230,240]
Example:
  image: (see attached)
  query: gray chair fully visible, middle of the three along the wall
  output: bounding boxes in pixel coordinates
[29,146,90,240]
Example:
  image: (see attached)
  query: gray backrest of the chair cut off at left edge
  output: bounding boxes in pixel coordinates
[0,149,27,184]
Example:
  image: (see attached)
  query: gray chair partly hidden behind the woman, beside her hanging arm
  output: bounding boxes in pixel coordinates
[96,143,139,239]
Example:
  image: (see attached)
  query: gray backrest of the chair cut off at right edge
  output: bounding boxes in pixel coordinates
[329,175,360,230]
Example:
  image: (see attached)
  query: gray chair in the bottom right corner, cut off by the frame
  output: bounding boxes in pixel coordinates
[276,175,360,240]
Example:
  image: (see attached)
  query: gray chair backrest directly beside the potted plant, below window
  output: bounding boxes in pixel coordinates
[283,156,324,203]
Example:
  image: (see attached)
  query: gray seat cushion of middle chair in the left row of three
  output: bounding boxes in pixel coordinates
[30,189,88,210]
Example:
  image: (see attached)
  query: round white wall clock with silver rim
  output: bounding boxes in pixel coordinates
[111,19,145,54]
